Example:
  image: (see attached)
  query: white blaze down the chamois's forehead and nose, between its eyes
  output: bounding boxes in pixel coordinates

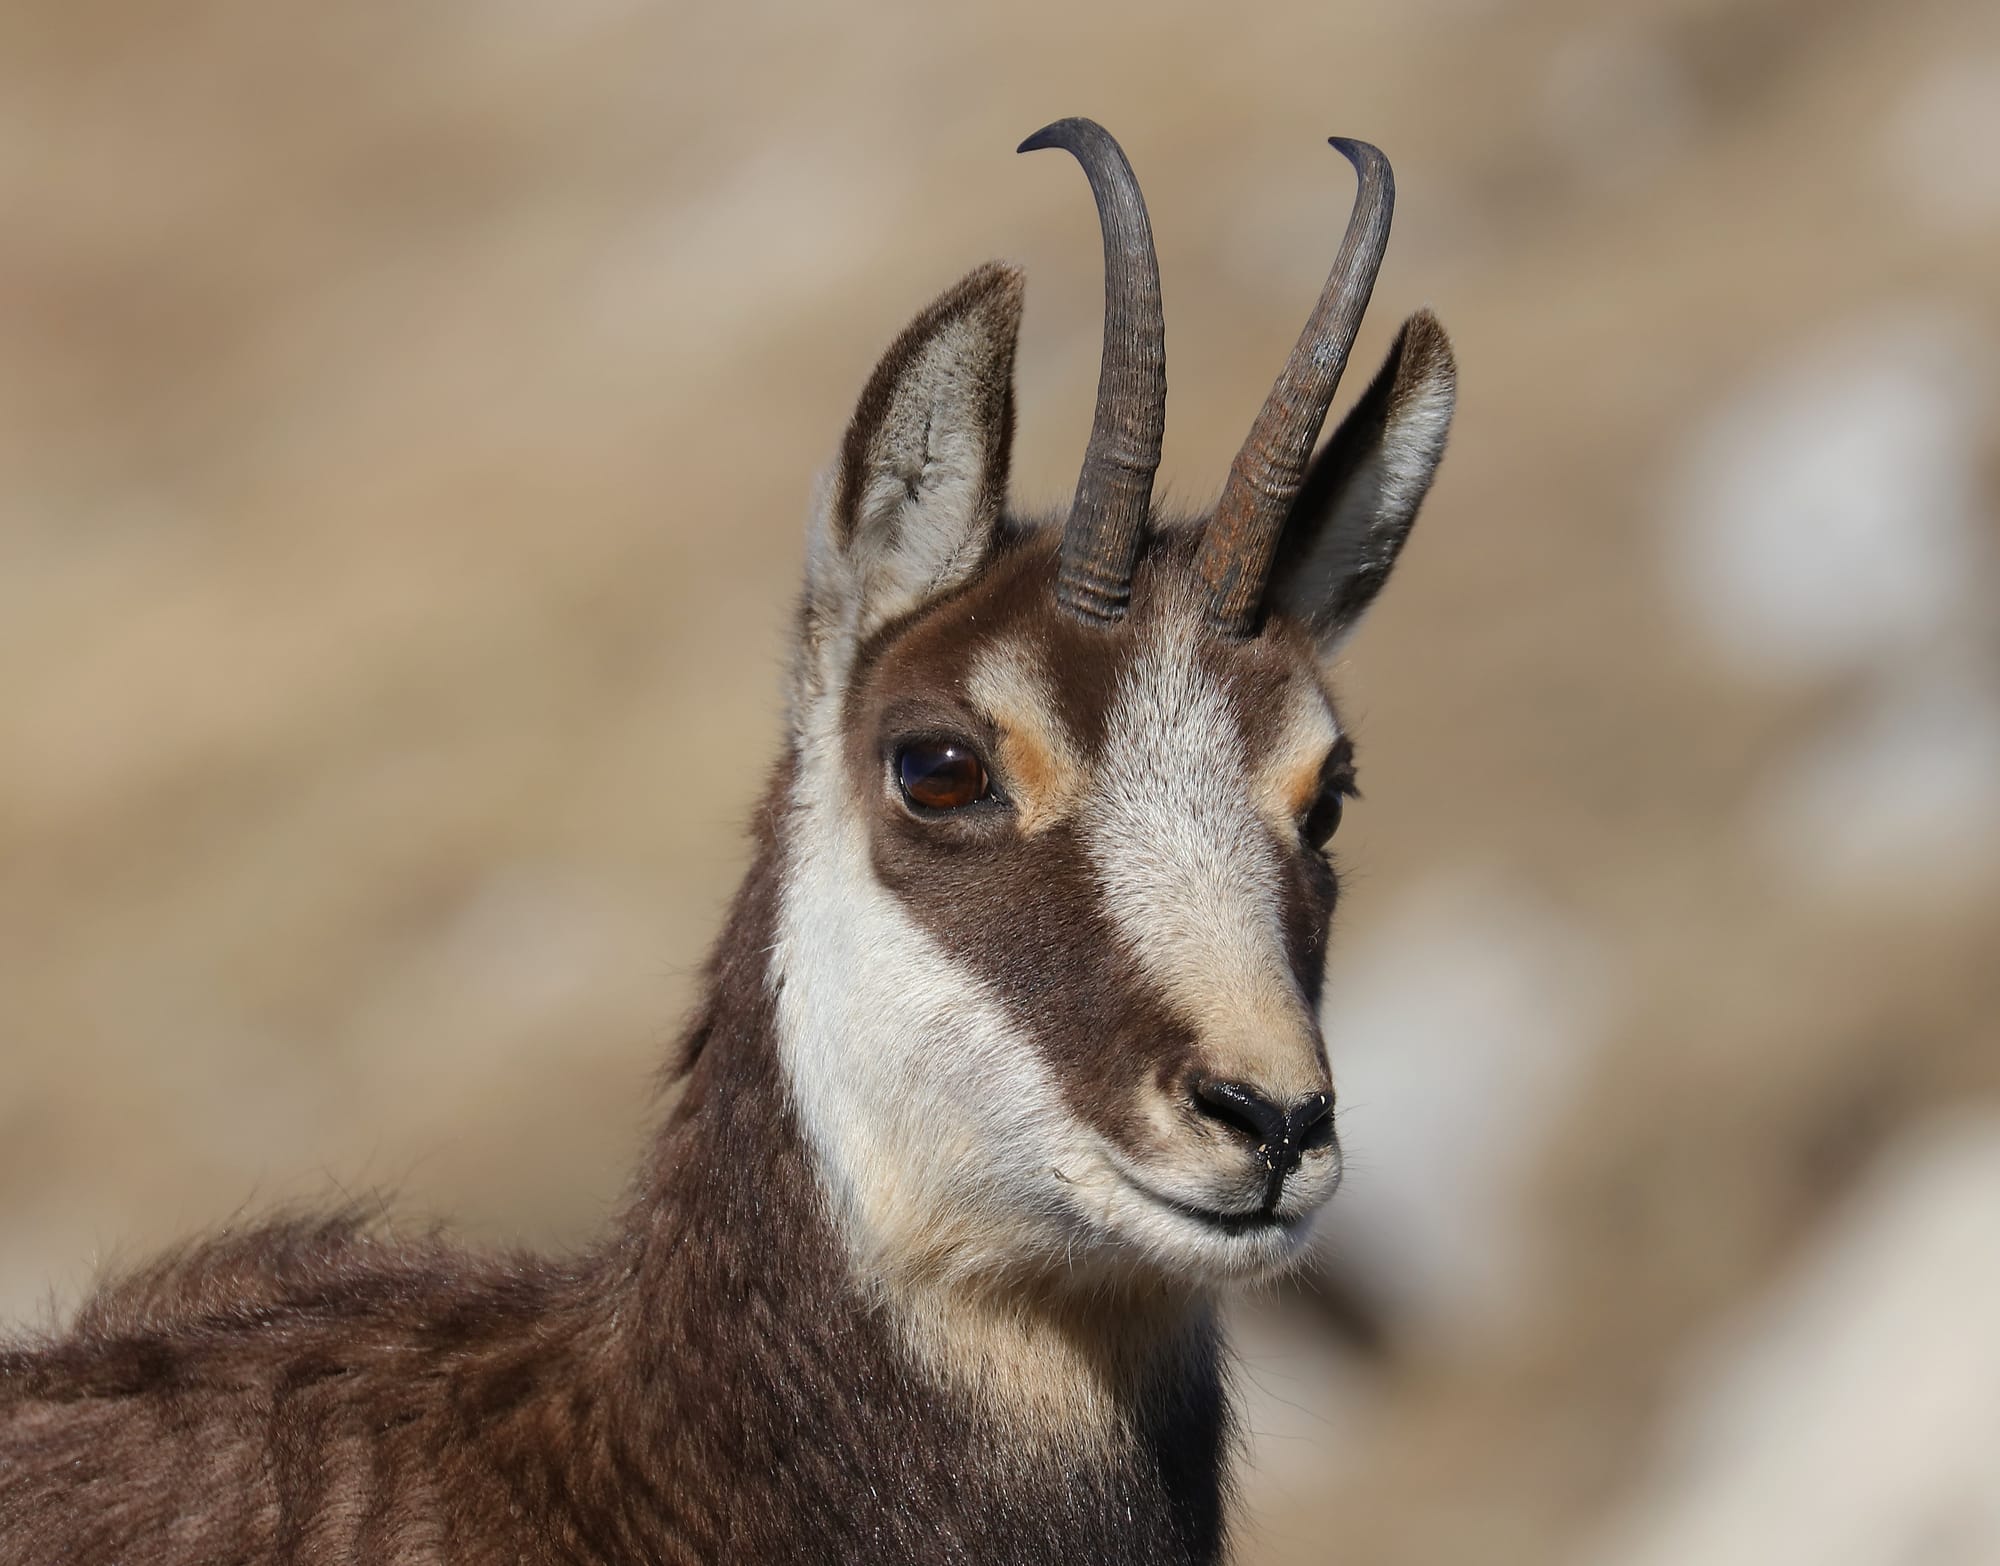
[1084,608,1324,1096]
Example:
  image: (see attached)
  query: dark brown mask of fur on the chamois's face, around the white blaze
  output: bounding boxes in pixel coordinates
[844,536,1336,1154]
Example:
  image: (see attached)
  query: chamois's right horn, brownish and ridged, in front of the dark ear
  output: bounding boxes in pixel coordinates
[1200,136,1396,636]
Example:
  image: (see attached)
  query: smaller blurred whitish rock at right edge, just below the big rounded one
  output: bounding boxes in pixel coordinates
[1752,660,2000,900]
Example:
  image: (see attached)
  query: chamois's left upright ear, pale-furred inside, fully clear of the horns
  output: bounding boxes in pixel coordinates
[806,264,1022,648]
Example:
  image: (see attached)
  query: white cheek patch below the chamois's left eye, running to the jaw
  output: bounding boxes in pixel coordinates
[772,712,1098,1286]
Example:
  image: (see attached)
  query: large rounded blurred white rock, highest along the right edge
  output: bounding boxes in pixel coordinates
[1664,308,1992,680]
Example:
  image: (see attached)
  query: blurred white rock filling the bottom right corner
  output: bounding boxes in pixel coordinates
[1582,1110,2000,1566]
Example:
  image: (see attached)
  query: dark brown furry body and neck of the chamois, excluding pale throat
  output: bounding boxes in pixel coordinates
[0,812,1222,1566]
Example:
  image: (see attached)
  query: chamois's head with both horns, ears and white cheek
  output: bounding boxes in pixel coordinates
[772,120,1454,1312]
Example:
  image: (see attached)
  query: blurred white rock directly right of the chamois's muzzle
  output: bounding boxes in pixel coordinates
[1322,878,1610,1336]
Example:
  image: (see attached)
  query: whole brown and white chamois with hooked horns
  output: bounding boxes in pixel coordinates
[0,120,1456,1566]
